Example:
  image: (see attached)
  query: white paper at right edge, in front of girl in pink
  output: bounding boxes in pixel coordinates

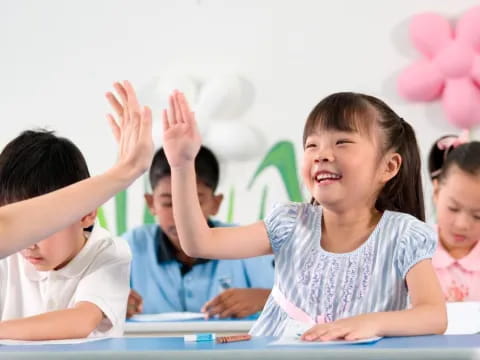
[445,301,480,335]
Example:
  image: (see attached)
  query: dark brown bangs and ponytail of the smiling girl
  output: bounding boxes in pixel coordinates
[303,92,425,220]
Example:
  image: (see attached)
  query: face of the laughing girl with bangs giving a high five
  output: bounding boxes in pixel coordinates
[302,128,401,210]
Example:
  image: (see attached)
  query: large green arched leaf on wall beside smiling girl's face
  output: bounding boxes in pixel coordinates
[248,141,303,202]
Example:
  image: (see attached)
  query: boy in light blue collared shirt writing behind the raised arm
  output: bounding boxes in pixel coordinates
[124,147,274,317]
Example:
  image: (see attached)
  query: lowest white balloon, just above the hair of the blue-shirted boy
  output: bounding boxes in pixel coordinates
[204,121,265,161]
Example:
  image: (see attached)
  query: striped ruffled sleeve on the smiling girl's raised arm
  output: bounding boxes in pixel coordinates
[264,203,300,253]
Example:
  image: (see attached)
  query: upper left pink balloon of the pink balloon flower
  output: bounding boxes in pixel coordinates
[410,13,453,58]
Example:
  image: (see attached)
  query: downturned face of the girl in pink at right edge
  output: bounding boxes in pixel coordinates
[434,165,480,255]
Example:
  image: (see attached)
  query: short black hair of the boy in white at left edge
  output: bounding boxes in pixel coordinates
[0,130,90,206]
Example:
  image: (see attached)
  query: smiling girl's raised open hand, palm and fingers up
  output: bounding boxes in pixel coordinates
[163,91,202,168]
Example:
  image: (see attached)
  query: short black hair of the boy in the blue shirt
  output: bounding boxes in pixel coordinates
[149,146,220,192]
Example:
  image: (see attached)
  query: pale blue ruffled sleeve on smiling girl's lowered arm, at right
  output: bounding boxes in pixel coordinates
[395,219,437,279]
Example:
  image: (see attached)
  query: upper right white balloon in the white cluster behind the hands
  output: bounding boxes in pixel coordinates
[196,74,254,120]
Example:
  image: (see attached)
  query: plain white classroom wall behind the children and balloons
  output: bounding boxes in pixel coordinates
[0,0,478,231]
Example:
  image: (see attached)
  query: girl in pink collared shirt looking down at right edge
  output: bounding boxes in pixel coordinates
[429,136,480,301]
